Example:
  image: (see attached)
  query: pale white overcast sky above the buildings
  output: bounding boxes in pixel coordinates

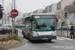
[0,0,60,13]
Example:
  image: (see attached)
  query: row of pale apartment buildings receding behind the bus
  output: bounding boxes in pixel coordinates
[22,0,75,26]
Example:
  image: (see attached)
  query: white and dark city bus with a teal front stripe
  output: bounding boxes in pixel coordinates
[22,13,58,41]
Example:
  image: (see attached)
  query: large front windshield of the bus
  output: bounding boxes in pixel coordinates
[32,18,56,30]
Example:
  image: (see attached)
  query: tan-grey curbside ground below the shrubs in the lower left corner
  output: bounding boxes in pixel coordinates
[0,38,25,50]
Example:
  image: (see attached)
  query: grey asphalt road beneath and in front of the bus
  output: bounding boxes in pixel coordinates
[10,29,75,50]
